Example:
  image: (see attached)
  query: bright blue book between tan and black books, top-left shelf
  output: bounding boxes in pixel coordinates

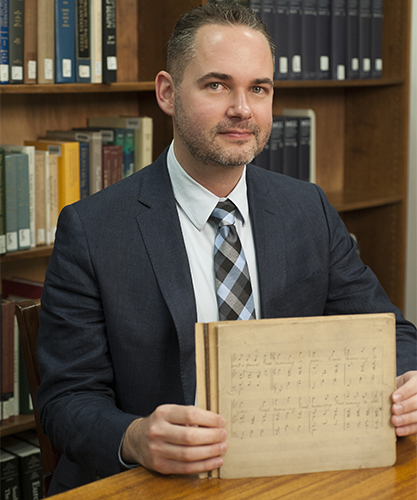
[55,0,75,83]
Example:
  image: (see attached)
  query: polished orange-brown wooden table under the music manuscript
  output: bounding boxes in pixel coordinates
[53,436,417,500]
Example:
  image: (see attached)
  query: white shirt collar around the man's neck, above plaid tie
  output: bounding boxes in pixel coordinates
[167,141,249,231]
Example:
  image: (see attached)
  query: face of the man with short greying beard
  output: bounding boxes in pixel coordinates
[174,25,273,172]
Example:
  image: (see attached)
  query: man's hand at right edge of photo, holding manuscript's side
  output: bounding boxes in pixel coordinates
[391,371,417,436]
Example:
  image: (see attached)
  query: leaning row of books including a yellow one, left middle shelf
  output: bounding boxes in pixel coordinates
[0,117,153,254]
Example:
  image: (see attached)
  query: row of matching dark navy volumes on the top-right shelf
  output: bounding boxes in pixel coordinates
[249,0,383,80]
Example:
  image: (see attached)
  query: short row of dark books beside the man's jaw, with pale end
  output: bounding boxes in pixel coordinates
[253,109,316,182]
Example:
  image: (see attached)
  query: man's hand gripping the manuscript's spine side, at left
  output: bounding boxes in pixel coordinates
[121,405,227,474]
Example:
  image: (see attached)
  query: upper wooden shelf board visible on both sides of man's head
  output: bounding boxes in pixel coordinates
[0,77,404,94]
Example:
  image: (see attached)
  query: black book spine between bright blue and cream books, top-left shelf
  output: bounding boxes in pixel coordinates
[75,0,91,83]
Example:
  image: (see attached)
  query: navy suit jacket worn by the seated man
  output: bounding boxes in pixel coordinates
[38,148,417,488]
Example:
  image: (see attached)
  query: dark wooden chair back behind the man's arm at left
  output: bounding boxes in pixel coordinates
[15,299,61,496]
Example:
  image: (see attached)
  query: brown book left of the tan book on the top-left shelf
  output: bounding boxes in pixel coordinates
[23,0,38,84]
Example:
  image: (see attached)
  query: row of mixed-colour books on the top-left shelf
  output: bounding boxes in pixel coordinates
[0,0,117,84]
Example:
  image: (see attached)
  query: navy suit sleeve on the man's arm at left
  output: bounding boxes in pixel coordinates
[37,206,137,477]
